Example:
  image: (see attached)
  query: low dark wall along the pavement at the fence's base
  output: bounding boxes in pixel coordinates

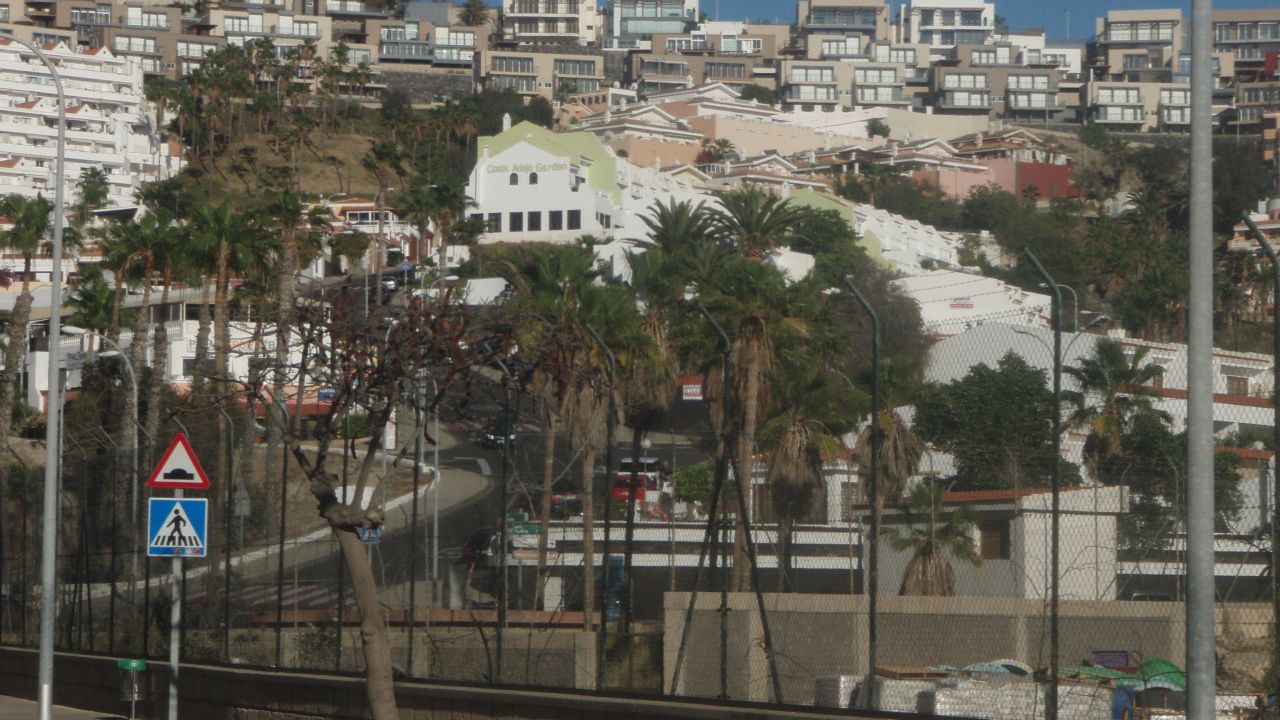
[0,648,880,720]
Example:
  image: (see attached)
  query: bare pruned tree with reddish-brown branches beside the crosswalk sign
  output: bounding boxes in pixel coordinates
[241,288,507,720]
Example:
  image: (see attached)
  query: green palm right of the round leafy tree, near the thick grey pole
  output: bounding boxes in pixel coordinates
[1062,338,1165,480]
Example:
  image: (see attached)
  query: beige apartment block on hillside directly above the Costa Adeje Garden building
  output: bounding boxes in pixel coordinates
[472,50,604,100]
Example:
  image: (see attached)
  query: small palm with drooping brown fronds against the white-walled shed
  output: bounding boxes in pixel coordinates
[884,483,982,596]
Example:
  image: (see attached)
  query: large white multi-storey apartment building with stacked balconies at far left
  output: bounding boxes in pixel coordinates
[0,37,182,210]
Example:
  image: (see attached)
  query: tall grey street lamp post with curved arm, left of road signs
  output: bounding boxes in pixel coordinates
[8,36,67,720]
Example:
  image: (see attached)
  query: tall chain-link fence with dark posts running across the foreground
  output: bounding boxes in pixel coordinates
[0,298,1276,719]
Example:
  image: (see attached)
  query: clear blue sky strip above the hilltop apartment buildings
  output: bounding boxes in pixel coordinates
[716,0,1277,40]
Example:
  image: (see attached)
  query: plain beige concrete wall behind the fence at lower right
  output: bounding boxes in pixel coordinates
[663,593,1192,703]
